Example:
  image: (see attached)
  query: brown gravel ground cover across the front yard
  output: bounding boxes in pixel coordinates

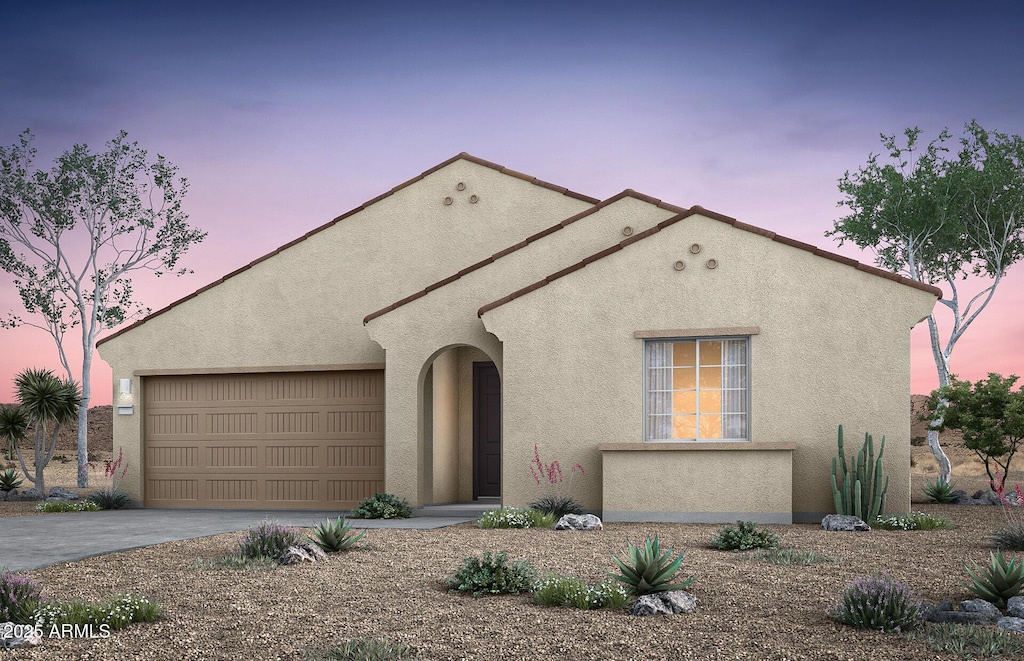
[0,503,1004,659]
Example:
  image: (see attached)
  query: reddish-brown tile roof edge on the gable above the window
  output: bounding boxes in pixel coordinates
[476,206,942,317]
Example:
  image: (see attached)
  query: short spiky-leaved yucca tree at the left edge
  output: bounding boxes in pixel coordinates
[0,369,82,496]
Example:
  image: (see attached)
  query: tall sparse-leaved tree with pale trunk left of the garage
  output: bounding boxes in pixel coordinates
[0,131,206,487]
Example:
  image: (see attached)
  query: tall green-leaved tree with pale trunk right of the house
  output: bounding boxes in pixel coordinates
[825,122,1024,482]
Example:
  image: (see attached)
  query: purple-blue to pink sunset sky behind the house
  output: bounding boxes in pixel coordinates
[0,1,1024,404]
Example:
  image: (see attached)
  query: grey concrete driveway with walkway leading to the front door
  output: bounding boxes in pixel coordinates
[0,510,478,571]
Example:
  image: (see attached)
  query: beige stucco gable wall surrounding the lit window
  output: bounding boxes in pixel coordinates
[483,216,935,521]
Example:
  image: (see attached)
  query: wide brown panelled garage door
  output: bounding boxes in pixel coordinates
[142,370,384,510]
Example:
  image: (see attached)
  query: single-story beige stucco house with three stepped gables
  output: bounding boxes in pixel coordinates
[99,153,941,523]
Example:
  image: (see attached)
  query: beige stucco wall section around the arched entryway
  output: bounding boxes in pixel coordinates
[367,197,675,503]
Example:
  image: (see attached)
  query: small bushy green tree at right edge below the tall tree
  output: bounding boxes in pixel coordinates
[929,373,1024,481]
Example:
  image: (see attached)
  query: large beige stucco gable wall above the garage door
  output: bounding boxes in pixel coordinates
[99,161,590,499]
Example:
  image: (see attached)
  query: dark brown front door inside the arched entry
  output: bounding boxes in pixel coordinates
[473,362,502,498]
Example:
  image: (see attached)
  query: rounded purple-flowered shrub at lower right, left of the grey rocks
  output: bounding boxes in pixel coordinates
[828,574,922,633]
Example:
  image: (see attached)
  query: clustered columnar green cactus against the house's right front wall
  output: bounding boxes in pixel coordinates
[831,425,889,522]
